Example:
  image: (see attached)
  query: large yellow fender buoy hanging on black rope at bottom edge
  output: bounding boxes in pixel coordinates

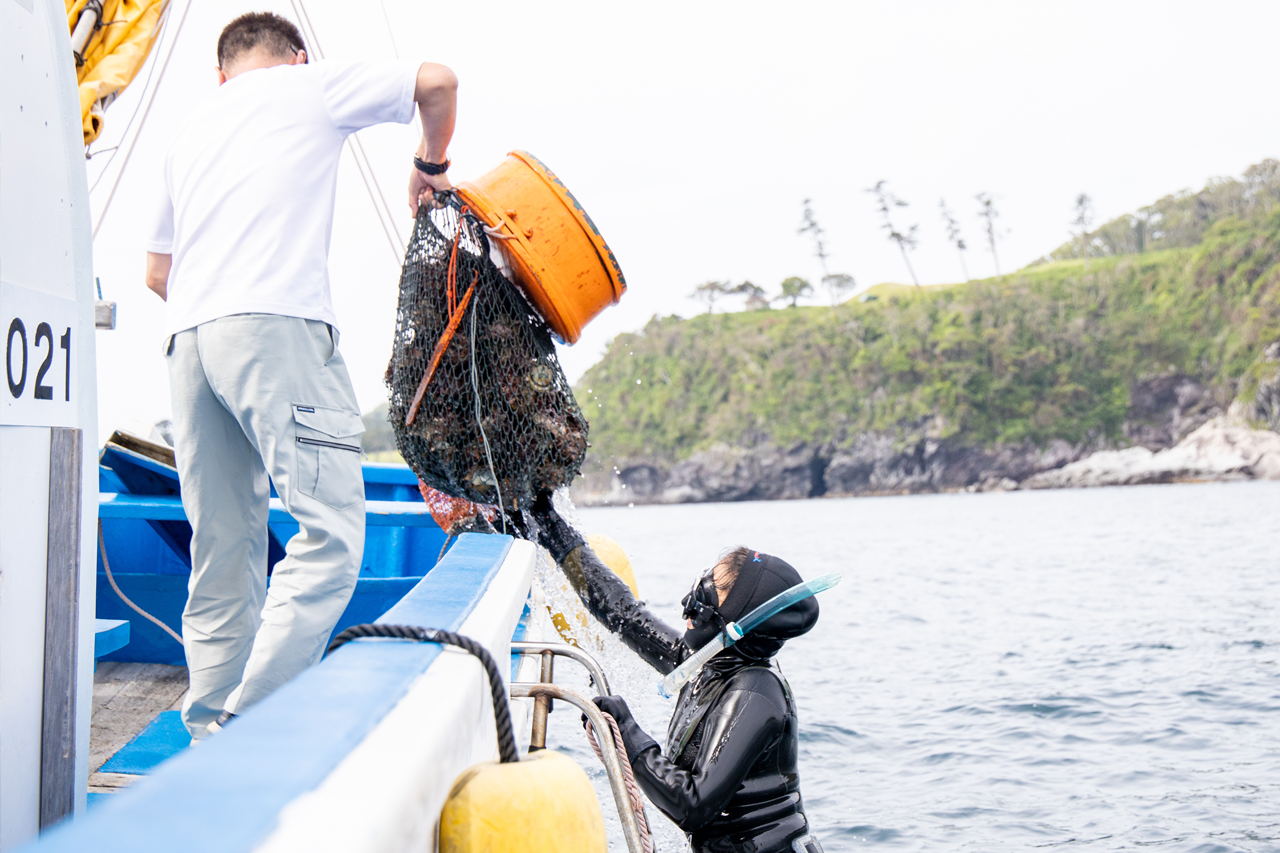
[439,749,608,853]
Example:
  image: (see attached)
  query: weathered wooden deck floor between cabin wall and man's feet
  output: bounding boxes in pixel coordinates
[88,661,187,794]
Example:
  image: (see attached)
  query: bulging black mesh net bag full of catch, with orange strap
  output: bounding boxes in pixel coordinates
[387,193,588,510]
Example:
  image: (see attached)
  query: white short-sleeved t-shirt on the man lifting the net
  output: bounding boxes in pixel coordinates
[146,61,419,336]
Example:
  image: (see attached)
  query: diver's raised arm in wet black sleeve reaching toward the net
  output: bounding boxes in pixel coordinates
[532,493,689,675]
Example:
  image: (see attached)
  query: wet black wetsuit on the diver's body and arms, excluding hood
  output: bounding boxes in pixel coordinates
[539,499,822,853]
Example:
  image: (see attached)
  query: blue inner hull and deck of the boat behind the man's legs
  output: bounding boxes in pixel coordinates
[88,433,460,803]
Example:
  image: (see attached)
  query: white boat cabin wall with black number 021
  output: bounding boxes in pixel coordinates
[0,0,97,852]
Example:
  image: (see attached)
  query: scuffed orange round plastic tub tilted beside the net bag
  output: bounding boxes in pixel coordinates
[457,151,627,343]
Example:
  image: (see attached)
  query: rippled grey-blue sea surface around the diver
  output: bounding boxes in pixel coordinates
[549,483,1280,853]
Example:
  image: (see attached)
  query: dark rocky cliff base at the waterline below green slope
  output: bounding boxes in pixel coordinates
[575,375,1233,506]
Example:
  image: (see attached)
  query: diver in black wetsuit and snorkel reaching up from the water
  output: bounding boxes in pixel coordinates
[534,498,822,853]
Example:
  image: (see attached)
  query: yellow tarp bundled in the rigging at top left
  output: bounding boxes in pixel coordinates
[65,0,169,145]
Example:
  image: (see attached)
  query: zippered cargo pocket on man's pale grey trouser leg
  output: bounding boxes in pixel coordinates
[293,405,365,510]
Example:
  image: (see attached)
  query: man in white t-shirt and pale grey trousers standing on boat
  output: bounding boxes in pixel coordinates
[146,13,457,739]
